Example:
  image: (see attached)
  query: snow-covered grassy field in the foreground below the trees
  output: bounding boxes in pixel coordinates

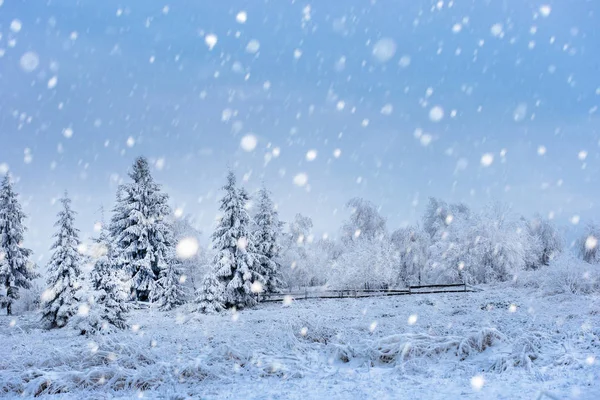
[0,284,600,399]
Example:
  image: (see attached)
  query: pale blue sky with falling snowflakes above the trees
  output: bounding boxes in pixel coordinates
[0,0,600,257]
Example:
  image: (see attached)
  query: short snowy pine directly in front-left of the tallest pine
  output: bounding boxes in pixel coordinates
[73,209,129,334]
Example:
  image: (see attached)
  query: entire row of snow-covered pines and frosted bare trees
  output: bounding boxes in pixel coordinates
[0,157,600,333]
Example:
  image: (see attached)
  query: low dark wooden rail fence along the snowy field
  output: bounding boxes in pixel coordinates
[257,283,481,303]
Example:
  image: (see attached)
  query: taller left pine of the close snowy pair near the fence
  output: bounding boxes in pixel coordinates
[212,171,265,308]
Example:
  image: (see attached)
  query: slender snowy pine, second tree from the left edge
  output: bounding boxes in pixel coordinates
[42,192,83,328]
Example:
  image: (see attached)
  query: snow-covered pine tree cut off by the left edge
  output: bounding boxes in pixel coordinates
[0,174,38,315]
